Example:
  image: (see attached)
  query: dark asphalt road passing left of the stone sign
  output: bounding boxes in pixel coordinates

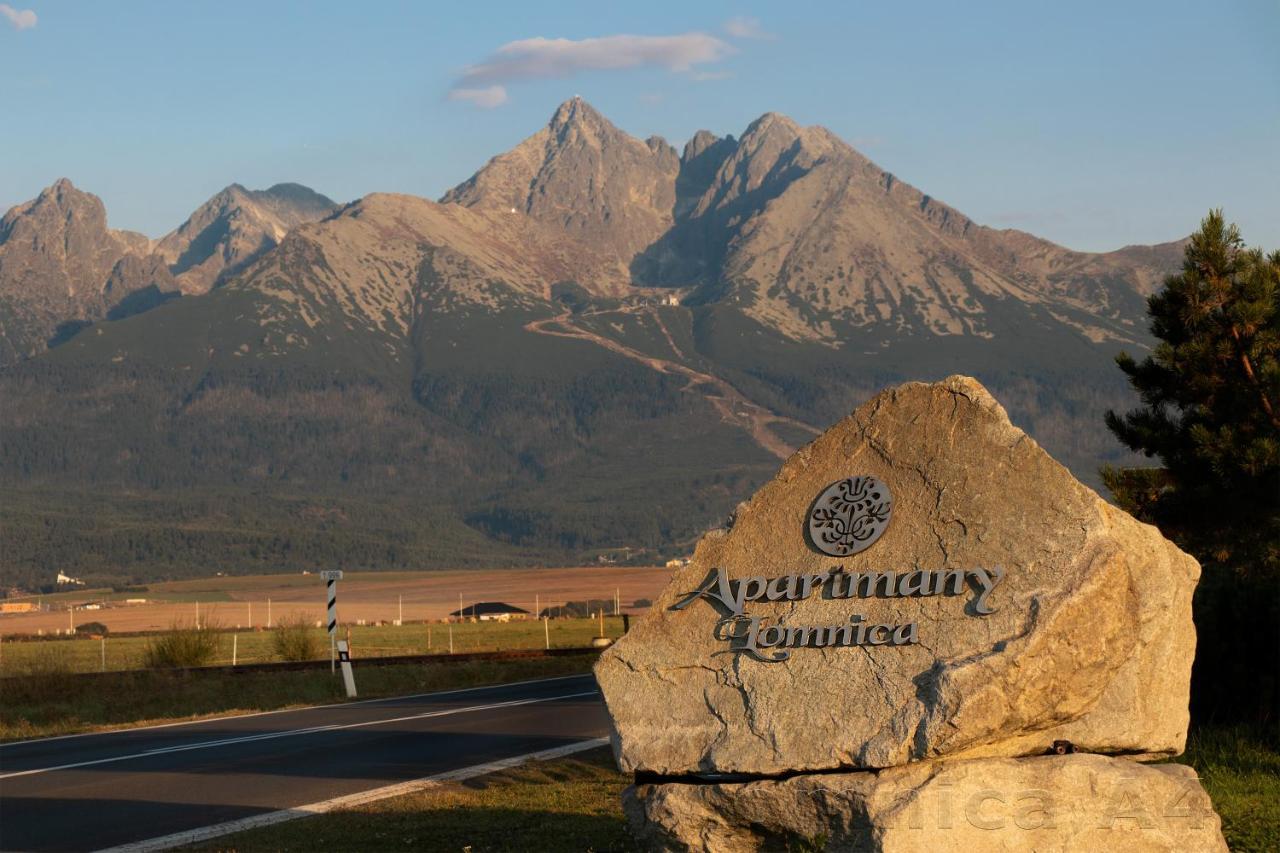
[0,675,608,850]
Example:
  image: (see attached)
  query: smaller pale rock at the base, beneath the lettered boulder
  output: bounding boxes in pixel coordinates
[623,754,1226,853]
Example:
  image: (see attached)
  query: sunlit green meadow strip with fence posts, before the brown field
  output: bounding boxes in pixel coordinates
[0,610,622,676]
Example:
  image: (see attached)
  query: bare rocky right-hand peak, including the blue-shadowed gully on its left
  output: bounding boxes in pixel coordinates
[637,114,1180,342]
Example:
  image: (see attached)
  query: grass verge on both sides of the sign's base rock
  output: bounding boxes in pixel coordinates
[191,727,1280,853]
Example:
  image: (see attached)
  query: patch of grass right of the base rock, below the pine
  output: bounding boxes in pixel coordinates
[1178,727,1280,853]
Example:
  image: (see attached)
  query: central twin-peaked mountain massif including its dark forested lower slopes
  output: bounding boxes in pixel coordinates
[0,101,1178,584]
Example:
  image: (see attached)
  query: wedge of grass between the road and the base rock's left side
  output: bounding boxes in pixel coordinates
[186,748,634,853]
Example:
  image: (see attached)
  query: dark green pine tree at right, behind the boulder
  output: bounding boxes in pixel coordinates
[1102,210,1280,726]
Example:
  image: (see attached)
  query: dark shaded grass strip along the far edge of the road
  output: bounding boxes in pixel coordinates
[0,654,595,740]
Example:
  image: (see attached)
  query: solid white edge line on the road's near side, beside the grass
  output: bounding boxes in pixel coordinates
[90,738,609,853]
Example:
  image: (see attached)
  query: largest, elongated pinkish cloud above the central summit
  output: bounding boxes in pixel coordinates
[449,32,735,106]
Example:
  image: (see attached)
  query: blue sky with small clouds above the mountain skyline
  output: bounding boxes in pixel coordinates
[0,0,1280,250]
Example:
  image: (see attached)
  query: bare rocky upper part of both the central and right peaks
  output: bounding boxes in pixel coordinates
[442,99,1180,345]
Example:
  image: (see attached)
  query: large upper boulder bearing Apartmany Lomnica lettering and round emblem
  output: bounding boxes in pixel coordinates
[595,377,1199,776]
